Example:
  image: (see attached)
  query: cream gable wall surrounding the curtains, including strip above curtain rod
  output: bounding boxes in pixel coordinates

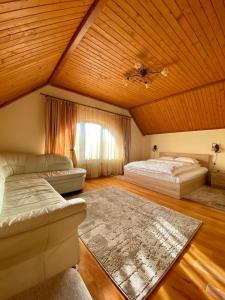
[0,85,148,160]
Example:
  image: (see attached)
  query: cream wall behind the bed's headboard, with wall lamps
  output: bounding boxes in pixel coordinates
[148,129,225,170]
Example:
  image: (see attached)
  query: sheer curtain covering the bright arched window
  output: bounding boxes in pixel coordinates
[75,105,124,178]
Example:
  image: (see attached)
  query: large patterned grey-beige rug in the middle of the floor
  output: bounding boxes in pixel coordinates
[79,186,201,300]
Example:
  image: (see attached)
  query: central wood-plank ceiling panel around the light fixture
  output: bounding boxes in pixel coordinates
[52,0,225,108]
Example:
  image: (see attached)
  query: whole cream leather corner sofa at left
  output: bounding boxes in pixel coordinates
[0,153,86,299]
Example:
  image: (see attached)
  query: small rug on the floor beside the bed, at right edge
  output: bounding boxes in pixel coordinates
[185,185,225,211]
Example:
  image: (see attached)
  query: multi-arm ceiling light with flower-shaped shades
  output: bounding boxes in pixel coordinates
[123,62,168,89]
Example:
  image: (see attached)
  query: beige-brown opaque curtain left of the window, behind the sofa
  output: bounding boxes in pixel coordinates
[45,96,77,166]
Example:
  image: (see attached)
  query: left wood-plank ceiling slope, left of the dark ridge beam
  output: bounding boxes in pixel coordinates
[0,0,93,106]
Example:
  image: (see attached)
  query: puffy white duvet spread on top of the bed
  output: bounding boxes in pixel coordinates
[124,159,200,176]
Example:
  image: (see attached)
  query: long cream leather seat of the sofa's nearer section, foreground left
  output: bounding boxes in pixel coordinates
[0,178,86,238]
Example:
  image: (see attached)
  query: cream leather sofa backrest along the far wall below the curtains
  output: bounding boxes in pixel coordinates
[0,152,73,177]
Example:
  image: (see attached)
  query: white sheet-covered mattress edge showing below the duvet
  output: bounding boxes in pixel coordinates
[124,167,208,183]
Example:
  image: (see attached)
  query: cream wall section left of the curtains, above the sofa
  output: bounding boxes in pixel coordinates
[0,86,45,153]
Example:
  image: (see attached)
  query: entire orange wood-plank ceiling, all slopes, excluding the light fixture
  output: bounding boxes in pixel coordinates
[0,0,225,134]
